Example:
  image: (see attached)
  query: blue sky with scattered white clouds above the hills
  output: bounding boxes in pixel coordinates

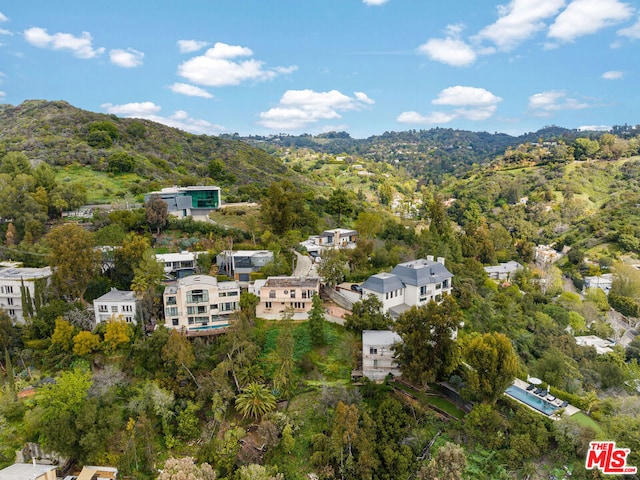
[0,0,640,138]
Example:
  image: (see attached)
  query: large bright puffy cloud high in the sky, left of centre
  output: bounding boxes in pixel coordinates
[178,42,297,87]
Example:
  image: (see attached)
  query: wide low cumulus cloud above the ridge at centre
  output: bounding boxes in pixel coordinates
[258,89,375,130]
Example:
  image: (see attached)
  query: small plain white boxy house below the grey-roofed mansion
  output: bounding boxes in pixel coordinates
[362,330,402,381]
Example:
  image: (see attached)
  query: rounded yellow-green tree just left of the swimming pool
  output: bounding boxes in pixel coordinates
[464,333,518,403]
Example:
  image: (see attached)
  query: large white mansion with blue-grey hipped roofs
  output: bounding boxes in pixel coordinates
[362,255,453,319]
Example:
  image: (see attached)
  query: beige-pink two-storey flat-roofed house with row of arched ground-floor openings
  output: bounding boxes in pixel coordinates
[256,277,320,320]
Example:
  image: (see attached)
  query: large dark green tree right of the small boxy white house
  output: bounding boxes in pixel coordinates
[393,295,462,387]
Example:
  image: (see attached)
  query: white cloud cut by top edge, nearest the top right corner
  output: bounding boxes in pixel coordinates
[548,0,633,42]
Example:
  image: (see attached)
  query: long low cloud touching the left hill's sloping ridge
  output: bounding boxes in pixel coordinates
[101,102,225,135]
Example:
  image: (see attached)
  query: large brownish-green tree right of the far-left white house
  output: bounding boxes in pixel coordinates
[46,223,100,300]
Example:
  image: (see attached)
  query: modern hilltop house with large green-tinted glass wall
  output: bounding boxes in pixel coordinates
[144,186,222,218]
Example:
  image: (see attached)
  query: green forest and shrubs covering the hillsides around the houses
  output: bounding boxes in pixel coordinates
[0,102,640,480]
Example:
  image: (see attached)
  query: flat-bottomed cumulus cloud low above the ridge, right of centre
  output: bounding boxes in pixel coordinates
[396,85,502,124]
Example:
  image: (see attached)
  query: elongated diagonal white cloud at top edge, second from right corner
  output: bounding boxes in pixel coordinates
[475,0,565,51]
